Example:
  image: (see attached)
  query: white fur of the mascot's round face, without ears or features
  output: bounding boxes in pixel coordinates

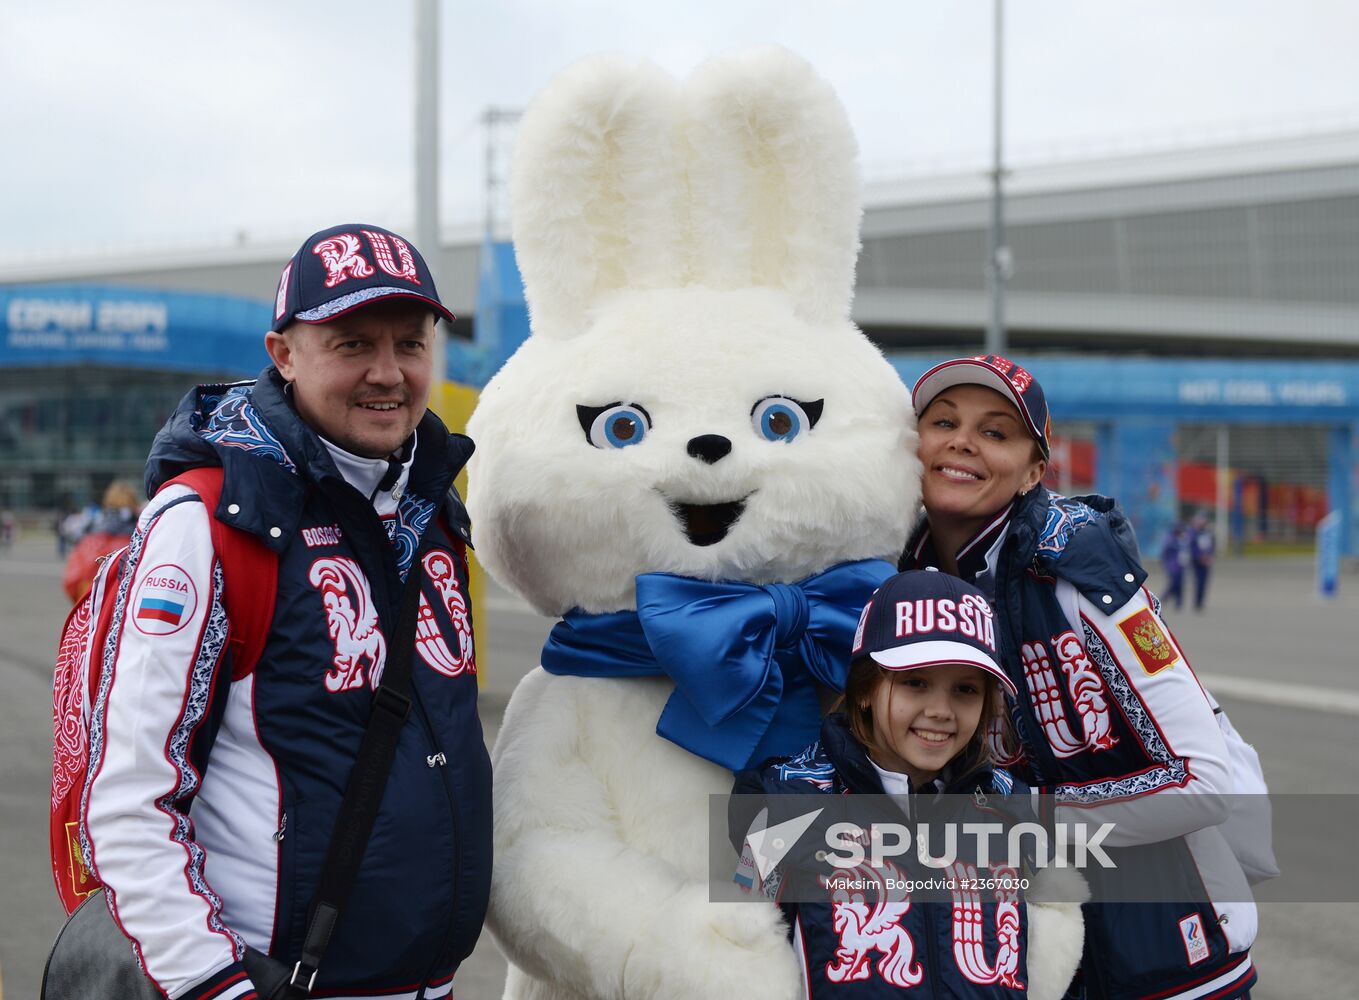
[469,287,917,614]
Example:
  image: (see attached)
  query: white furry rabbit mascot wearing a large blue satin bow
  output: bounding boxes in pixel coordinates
[469,49,1079,1000]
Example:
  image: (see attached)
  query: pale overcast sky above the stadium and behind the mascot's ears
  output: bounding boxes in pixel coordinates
[0,0,1359,264]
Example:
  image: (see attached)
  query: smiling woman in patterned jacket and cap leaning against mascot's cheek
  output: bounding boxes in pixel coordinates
[901,355,1257,1000]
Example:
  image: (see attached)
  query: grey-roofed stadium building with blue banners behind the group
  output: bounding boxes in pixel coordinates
[0,132,1359,554]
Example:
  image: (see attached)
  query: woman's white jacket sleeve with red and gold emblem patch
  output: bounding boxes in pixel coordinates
[1046,580,1233,846]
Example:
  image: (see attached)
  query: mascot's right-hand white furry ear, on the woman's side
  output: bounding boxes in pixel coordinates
[685,48,862,321]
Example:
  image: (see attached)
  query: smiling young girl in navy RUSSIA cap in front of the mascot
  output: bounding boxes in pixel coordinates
[737,571,1082,1000]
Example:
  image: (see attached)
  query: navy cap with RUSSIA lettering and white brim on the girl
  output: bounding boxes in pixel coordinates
[851,569,1018,694]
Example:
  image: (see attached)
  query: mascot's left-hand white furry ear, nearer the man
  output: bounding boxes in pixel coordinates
[510,56,685,337]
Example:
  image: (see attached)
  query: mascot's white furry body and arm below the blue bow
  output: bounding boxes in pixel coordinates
[489,670,800,997]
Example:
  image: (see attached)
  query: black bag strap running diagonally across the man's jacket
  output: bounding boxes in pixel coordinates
[289,524,434,995]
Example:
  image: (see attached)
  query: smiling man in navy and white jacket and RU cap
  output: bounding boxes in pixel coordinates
[83,224,491,1000]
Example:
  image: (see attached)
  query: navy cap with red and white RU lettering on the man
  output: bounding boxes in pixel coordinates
[269,223,454,333]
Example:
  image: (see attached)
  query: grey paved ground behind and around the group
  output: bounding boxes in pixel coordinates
[0,538,1359,1000]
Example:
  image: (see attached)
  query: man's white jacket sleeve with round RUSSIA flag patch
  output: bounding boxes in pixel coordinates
[82,485,255,1000]
